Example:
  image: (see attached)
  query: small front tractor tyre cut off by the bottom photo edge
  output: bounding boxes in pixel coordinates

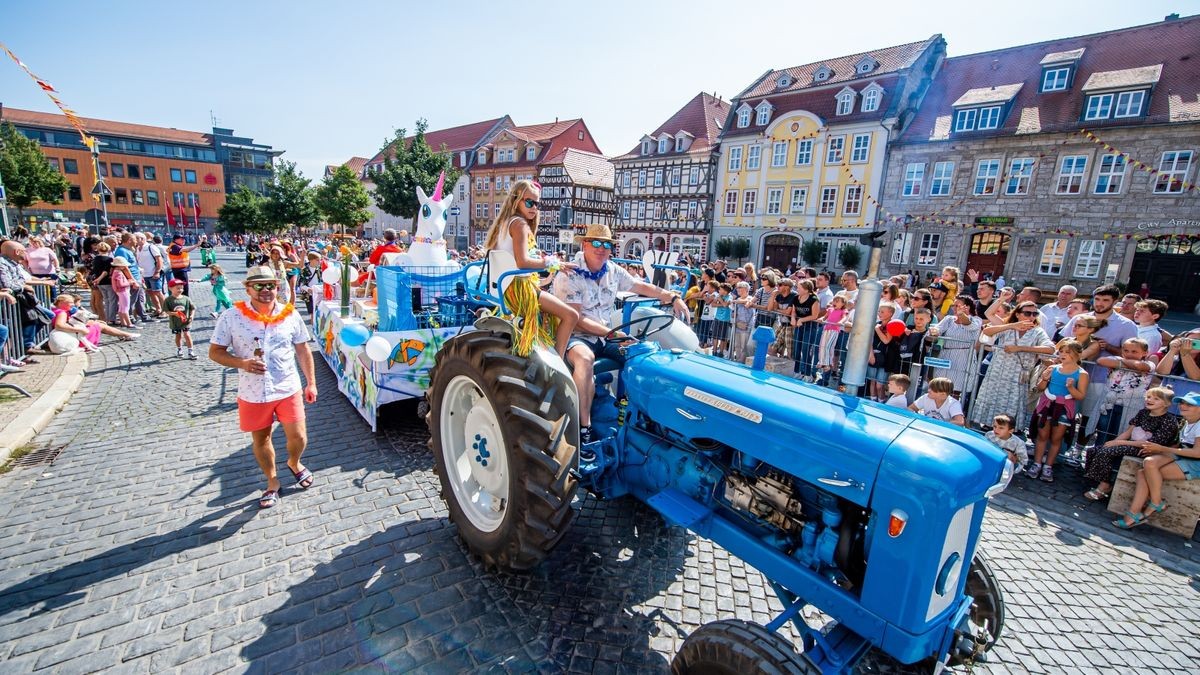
[671,619,821,675]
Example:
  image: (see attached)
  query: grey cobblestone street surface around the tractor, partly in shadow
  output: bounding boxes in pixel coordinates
[0,253,1200,673]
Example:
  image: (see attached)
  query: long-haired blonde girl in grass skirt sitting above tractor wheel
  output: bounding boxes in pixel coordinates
[484,179,580,358]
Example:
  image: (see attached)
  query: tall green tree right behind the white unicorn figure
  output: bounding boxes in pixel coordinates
[368,119,462,219]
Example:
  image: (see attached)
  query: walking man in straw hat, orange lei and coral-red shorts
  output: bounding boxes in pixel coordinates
[209,265,317,508]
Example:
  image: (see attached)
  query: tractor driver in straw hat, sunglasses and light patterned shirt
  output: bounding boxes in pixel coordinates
[553,225,690,443]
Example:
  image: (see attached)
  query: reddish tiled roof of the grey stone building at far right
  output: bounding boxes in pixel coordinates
[899,16,1200,143]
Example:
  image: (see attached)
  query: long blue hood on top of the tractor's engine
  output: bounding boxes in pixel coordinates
[622,350,1004,507]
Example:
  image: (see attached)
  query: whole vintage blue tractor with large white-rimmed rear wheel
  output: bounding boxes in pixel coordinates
[427,296,1012,674]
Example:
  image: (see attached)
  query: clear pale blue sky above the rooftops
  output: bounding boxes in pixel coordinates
[0,0,1180,179]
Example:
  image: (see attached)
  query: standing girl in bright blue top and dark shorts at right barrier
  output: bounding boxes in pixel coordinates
[1025,338,1087,483]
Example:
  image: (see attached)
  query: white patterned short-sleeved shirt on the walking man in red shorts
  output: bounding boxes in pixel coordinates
[209,305,312,404]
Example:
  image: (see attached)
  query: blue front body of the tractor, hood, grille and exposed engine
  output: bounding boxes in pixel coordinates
[590,344,1007,663]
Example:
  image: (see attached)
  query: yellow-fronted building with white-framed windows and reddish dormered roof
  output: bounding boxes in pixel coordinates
[713,35,946,269]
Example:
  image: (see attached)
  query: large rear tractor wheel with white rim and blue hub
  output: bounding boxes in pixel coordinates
[426,330,578,572]
